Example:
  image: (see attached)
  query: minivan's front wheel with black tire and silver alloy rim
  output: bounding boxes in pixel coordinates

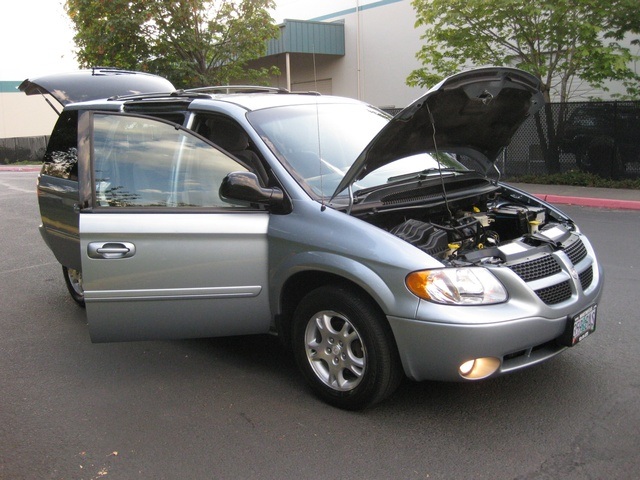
[292,286,403,410]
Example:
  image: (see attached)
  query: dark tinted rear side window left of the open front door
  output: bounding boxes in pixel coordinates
[42,110,78,180]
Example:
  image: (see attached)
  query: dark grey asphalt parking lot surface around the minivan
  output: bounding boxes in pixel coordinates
[0,172,640,480]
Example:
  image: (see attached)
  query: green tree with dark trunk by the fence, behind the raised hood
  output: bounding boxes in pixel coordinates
[407,0,640,173]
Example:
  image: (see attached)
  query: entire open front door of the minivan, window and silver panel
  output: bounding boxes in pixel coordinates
[80,114,271,342]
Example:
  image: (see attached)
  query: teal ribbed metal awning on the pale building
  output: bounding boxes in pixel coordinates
[267,20,344,56]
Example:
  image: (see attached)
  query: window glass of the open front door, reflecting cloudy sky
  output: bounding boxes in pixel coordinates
[93,114,247,208]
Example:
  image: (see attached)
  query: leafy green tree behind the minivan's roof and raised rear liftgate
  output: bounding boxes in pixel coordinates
[66,0,278,87]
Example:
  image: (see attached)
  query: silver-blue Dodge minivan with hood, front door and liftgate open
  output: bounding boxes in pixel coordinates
[21,67,603,409]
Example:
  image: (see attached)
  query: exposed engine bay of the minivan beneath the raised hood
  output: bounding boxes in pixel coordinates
[367,189,575,266]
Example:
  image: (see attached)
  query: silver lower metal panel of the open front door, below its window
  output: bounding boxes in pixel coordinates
[80,212,270,342]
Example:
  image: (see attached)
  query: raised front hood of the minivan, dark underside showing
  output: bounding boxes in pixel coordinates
[333,67,544,197]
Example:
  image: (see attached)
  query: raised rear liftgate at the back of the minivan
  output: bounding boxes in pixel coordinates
[18,68,175,107]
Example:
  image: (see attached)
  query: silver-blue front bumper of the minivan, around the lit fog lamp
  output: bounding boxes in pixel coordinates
[387,256,604,381]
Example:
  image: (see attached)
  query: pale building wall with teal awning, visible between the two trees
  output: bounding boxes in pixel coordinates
[254,0,423,108]
